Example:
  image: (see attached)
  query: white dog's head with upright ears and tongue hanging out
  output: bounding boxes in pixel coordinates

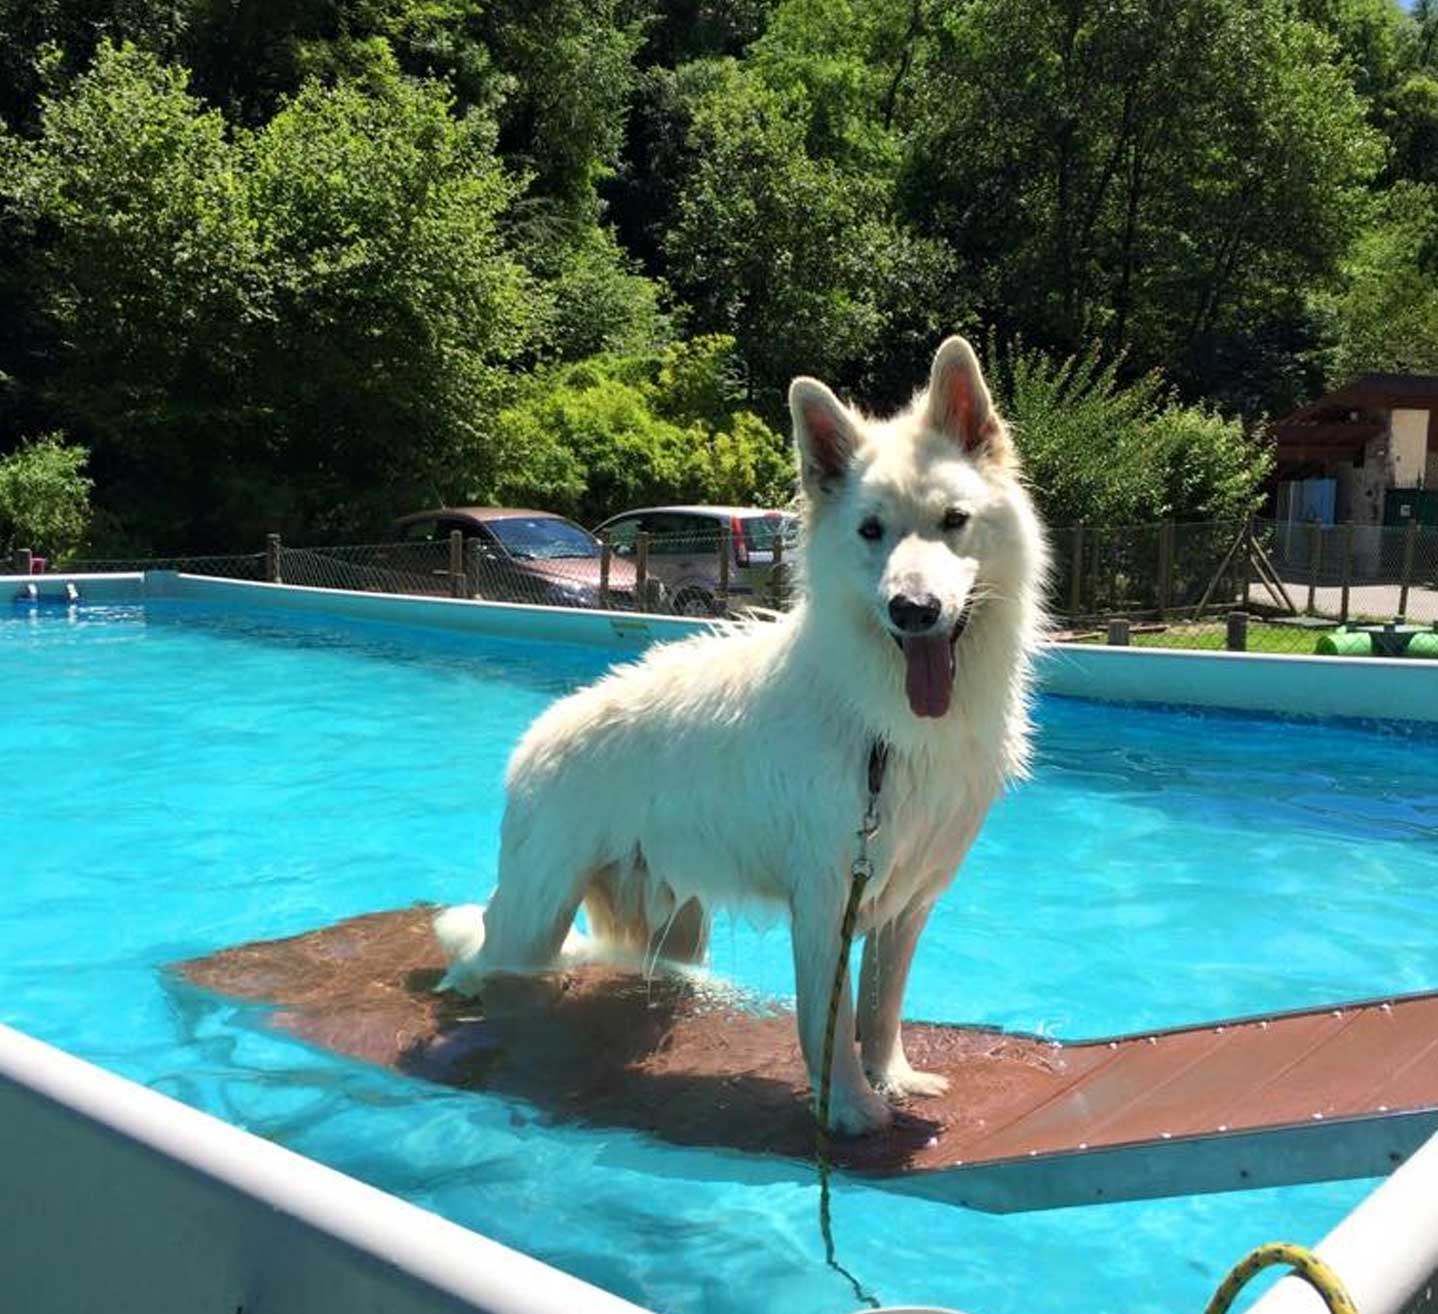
[789,327,1043,717]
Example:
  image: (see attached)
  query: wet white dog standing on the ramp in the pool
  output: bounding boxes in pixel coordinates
[436,338,1047,1134]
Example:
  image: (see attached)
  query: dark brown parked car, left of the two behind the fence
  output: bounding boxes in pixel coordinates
[390,506,636,610]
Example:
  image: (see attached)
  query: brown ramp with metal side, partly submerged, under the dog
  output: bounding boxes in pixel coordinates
[178,907,1438,1212]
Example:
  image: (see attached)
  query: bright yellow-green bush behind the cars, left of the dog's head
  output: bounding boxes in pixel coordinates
[491,338,792,525]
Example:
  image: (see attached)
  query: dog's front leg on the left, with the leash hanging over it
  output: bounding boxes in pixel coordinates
[791,884,893,1136]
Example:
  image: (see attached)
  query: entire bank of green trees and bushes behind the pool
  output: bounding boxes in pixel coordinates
[0,0,1438,551]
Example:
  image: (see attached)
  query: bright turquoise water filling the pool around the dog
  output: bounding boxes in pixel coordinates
[8,604,1438,1314]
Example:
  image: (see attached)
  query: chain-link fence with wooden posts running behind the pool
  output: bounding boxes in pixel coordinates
[17,520,1438,657]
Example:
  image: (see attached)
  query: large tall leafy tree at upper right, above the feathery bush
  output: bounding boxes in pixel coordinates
[900,0,1382,405]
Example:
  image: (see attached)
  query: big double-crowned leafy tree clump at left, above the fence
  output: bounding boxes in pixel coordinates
[0,46,535,548]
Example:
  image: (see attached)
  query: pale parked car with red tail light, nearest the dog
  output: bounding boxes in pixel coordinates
[595,506,798,615]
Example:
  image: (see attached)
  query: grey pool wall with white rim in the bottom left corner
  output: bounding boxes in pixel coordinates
[0,1026,643,1314]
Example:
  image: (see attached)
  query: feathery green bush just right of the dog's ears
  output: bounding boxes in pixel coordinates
[989,342,1271,525]
